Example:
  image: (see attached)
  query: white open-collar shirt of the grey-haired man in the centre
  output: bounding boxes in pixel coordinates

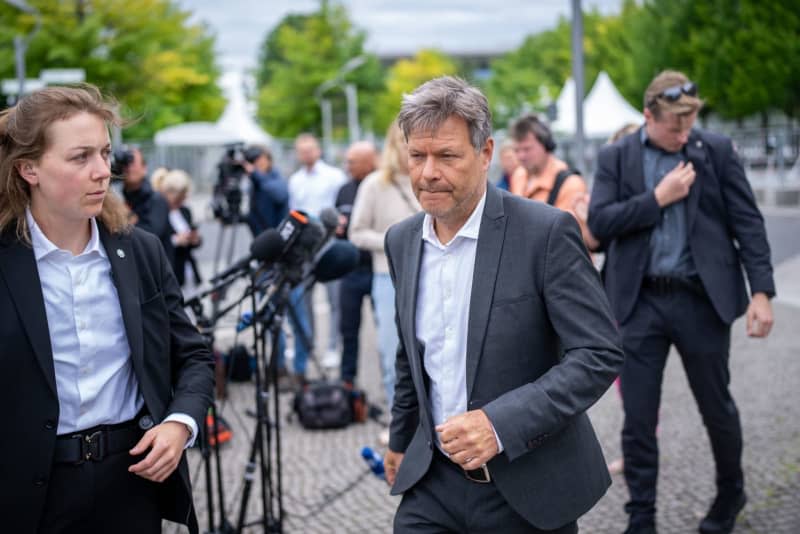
[415,192,503,452]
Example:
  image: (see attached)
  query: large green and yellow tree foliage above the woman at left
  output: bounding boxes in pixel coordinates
[0,0,225,139]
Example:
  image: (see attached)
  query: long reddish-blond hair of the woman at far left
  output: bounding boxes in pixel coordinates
[0,84,130,243]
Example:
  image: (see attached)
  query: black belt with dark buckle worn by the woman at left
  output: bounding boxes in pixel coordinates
[53,418,144,465]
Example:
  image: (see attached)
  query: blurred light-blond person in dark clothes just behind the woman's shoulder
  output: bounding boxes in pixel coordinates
[151,169,202,287]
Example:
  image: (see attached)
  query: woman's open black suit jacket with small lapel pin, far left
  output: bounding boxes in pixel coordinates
[0,222,214,534]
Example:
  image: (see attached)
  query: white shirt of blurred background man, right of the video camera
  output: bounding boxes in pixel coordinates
[289,160,347,217]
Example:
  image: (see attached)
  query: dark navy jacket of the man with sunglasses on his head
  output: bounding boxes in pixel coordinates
[589,130,775,324]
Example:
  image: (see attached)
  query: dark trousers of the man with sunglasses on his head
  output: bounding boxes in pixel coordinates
[621,287,744,523]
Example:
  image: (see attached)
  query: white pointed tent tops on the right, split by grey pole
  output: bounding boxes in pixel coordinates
[551,71,644,137]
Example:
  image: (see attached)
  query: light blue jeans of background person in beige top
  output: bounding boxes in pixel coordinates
[372,273,398,409]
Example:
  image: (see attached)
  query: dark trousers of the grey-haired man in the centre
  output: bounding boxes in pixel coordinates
[394,448,578,534]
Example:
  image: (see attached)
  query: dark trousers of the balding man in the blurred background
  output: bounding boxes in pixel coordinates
[339,267,372,382]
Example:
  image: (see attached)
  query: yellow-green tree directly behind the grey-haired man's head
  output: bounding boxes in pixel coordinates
[375,50,459,133]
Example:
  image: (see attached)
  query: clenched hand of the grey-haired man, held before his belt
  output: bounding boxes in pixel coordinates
[436,410,498,471]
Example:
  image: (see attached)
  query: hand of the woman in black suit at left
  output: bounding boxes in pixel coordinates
[128,421,191,482]
